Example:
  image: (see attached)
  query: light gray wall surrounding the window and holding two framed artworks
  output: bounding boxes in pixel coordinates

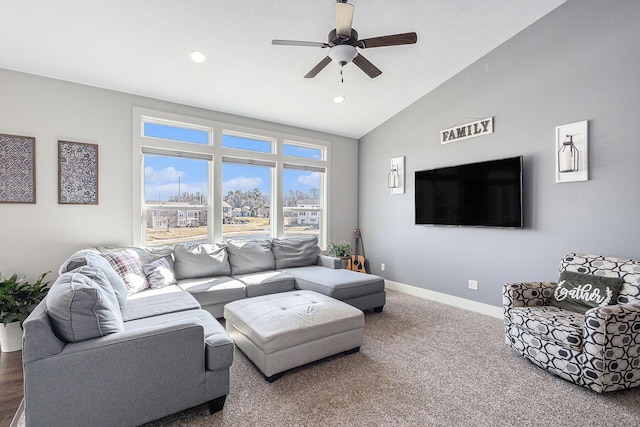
[0,69,358,278]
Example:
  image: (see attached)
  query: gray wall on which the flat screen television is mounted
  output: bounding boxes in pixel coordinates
[359,0,640,306]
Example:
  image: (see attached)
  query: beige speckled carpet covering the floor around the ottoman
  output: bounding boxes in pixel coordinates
[16,291,640,426]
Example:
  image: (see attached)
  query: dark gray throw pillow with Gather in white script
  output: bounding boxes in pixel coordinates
[551,271,624,313]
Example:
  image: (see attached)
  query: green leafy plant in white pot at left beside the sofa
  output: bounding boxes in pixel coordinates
[0,272,49,352]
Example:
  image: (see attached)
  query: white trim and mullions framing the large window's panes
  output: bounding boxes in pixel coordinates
[132,107,331,249]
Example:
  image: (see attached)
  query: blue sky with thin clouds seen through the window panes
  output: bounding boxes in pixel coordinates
[144,123,320,201]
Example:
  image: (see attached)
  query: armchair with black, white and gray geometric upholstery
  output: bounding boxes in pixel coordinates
[502,253,640,393]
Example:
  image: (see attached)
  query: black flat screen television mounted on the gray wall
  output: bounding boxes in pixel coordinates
[415,156,522,228]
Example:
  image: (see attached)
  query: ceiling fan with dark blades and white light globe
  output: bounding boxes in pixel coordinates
[271,0,418,79]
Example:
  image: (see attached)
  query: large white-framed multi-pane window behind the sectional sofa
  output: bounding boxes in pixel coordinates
[133,107,329,248]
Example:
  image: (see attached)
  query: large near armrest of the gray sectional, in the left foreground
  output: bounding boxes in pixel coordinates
[24,319,206,426]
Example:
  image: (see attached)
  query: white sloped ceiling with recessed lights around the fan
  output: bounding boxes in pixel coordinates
[0,0,565,138]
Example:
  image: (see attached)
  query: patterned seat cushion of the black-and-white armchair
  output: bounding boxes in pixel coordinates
[510,306,584,351]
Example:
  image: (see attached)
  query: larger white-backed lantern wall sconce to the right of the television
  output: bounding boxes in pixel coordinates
[556,120,589,182]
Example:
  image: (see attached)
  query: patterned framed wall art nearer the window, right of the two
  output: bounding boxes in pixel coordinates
[58,141,98,205]
